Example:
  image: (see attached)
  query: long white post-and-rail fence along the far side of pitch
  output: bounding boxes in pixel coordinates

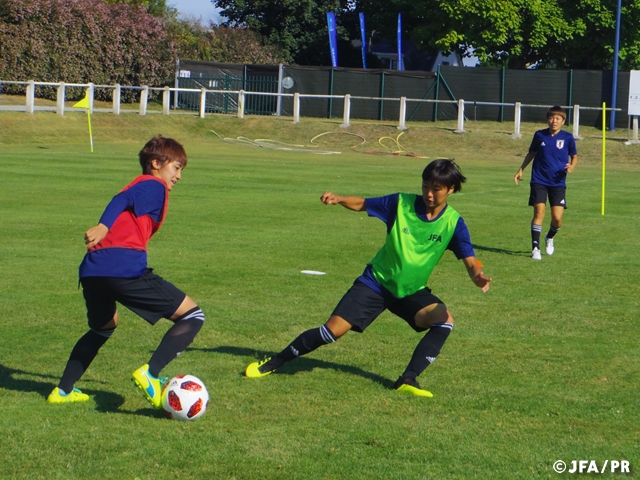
[0,80,638,142]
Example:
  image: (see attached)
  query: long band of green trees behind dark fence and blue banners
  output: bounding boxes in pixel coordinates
[212,0,640,69]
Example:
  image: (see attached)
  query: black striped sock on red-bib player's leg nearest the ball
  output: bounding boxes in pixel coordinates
[149,307,204,378]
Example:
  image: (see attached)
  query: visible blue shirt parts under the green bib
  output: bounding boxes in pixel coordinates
[358,193,475,296]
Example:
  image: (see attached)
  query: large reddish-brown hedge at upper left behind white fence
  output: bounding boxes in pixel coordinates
[0,0,177,98]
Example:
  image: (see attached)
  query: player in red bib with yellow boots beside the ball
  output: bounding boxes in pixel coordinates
[47,136,204,408]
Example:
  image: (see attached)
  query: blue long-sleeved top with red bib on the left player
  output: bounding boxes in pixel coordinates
[80,175,169,278]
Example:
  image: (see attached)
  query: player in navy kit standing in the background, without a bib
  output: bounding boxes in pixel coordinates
[513,106,578,260]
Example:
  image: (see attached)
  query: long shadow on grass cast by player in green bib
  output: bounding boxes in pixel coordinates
[189,346,394,388]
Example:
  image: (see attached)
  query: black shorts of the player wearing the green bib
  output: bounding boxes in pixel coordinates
[333,280,442,333]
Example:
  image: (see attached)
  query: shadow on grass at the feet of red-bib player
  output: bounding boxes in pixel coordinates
[0,365,124,412]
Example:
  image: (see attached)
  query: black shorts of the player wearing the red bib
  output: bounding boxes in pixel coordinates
[80,268,187,330]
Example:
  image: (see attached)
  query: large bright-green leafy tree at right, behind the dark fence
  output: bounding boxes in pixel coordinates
[357,0,640,69]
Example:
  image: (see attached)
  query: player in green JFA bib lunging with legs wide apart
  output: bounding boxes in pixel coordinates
[245,159,491,397]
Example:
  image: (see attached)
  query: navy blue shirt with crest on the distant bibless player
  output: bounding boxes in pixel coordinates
[529,128,578,187]
